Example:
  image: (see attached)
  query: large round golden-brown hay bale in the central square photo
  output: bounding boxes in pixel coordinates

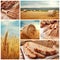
[22,24,36,37]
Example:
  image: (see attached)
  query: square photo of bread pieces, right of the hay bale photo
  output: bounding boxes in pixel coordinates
[40,19,59,40]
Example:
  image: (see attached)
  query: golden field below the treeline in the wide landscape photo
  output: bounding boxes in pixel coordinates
[21,10,59,19]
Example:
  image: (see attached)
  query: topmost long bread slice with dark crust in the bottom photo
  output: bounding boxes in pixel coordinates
[25,42,56,56]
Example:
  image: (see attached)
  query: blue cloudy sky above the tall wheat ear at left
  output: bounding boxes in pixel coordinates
[1,20,19,37]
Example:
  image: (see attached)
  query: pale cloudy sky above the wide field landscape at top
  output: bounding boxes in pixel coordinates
[21,0,59,8]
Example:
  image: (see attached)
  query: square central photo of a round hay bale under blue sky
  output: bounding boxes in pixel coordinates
[20,20,40,40]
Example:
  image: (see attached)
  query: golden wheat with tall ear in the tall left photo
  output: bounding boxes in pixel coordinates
[1,32,19,59]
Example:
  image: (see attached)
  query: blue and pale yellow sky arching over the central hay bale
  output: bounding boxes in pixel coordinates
[20,20,40,30]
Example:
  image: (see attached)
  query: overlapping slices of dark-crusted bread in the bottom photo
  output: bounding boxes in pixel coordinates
[24,42,57,58]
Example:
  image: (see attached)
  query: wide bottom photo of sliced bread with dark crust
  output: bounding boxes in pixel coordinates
[20,40,59,60]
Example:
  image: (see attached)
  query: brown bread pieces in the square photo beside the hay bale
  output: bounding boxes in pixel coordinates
[41,20,59,39]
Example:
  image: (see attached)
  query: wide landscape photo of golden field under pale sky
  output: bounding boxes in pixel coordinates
[21,0,59,19]
